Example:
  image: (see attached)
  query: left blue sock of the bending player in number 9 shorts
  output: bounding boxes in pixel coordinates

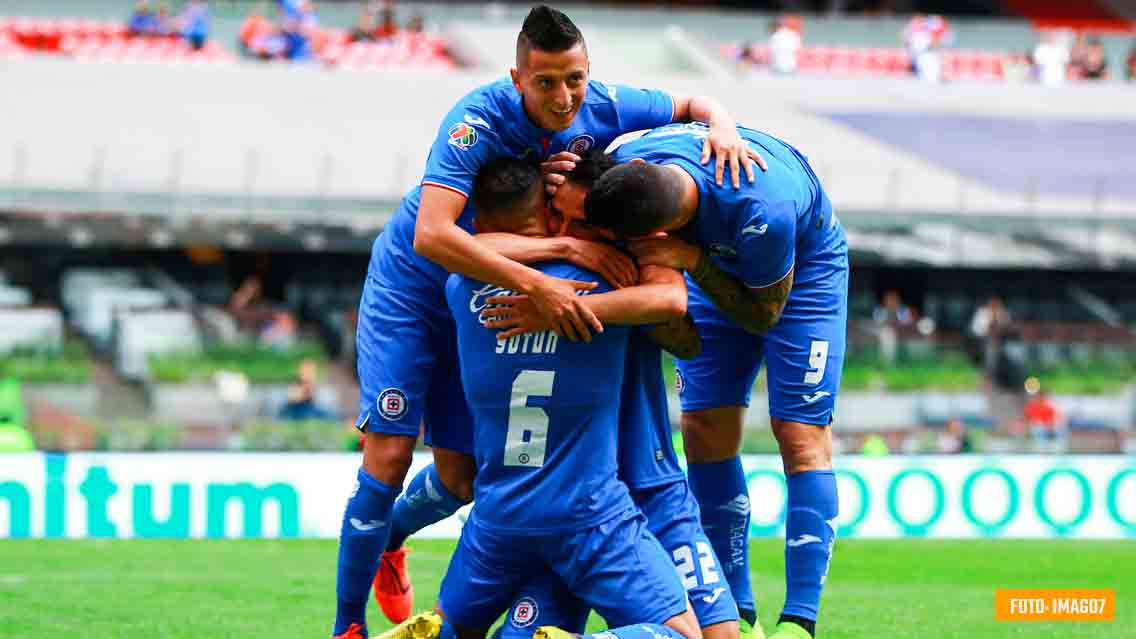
[687,457,757,616]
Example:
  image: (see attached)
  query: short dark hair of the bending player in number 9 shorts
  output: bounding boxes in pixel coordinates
[584,161,682,238]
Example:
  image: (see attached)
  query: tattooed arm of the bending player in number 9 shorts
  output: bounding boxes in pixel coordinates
[632,236,793,335]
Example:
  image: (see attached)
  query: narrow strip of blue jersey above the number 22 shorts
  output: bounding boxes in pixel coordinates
[619,330,683,490]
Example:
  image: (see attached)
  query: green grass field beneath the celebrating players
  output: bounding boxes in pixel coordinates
[0,539,1136,639]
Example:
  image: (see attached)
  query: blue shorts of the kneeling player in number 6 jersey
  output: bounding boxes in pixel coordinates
[438,508,686,637]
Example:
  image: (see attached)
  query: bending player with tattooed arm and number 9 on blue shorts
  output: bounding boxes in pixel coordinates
[493,124,849,639]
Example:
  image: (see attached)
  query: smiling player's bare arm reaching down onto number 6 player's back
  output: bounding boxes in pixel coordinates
[415,184,603,341]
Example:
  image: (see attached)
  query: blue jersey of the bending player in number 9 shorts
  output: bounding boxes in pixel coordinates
[616,123,846,288]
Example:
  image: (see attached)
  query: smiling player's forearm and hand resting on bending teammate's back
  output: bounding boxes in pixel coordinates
[673,96,768,189]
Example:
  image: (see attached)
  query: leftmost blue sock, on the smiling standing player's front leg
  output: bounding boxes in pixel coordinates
[332,467,401,634]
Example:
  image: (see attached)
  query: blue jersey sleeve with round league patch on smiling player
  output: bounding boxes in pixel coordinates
[421,106,499,197]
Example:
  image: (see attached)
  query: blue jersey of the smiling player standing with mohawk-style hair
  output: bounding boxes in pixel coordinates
[369,78,674,290]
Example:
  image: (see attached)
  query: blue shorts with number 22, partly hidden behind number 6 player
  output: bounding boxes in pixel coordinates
[498,478,737,639]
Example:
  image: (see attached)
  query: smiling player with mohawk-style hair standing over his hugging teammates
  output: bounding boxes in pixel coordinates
[333,6,762,637]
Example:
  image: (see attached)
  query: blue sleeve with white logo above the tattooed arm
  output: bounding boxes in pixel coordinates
[737,201,796,289]
